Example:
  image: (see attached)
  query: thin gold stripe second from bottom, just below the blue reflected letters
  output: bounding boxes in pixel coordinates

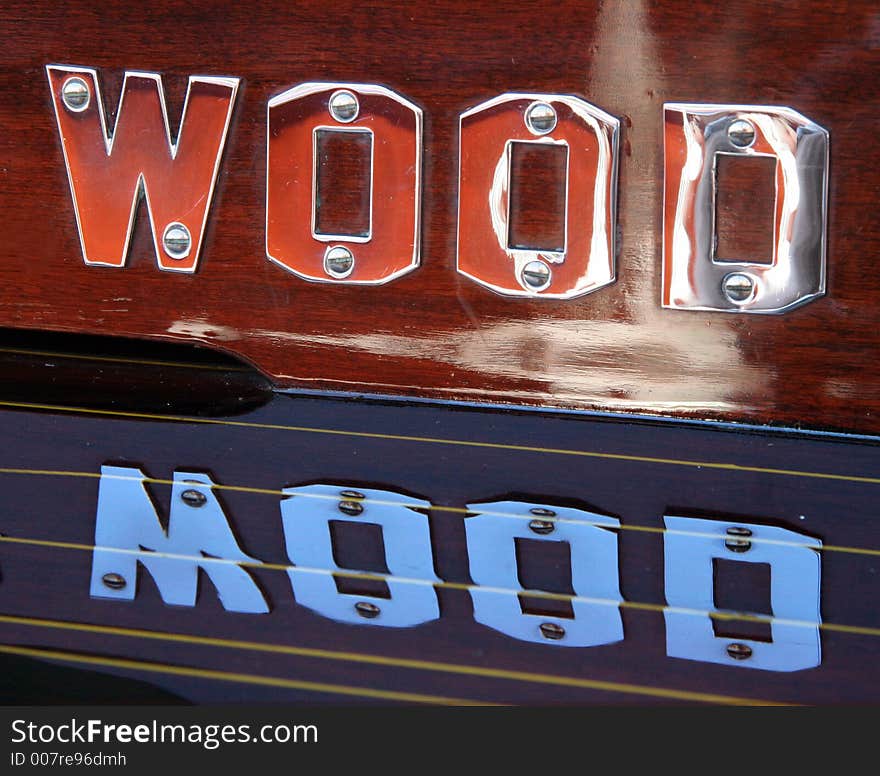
[0,615,790,706]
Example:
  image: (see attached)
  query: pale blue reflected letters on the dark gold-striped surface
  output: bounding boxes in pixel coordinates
[90,466,822,671]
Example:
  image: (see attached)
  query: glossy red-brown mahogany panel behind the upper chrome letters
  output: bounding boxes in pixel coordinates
[0,0,880,432]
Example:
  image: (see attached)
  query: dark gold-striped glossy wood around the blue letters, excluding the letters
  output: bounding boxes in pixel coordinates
[0,384,880,705]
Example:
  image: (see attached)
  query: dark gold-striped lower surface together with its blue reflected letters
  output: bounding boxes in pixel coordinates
[0,396,880,703]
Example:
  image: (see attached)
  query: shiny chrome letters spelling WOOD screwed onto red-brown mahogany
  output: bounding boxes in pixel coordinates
[46,65,828,313]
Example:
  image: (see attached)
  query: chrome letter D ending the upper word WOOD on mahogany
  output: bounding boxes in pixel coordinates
[663,103,828,313]
